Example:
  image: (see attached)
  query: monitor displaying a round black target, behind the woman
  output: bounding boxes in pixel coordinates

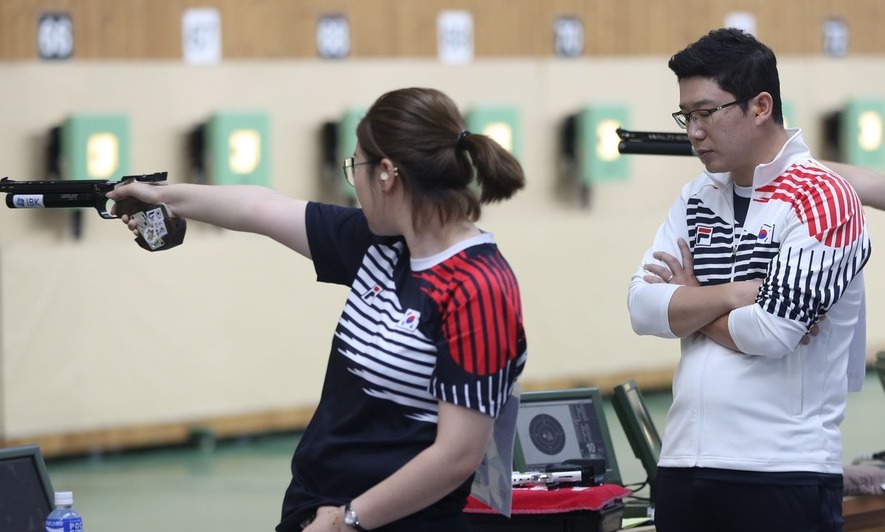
[513,387,621,484]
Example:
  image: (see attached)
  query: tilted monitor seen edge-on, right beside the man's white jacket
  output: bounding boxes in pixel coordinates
[612,379,661,499]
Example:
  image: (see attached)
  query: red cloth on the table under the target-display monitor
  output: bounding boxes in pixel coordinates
[464,484,631,514]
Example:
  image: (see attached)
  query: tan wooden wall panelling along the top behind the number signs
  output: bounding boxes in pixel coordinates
[0,0,885,60]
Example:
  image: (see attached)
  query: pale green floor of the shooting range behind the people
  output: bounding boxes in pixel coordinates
[47,372,885,532]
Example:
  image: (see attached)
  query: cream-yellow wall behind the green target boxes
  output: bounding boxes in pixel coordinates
[0,56,885,454]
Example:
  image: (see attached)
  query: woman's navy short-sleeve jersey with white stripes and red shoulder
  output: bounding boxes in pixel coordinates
[278,203,526,530]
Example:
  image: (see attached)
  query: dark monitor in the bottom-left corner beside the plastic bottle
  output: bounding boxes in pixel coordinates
[0,445,55,532]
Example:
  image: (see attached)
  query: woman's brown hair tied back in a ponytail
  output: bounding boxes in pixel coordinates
[356,88,525,226]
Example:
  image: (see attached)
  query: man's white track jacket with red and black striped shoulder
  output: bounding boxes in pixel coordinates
[628,130,870,473]
